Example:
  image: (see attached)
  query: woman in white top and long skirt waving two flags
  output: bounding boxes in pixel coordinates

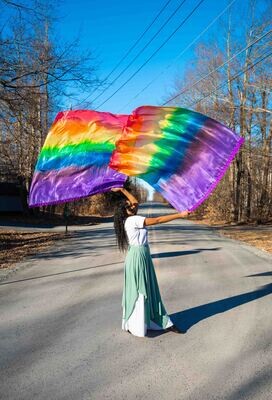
[112,188,189,337]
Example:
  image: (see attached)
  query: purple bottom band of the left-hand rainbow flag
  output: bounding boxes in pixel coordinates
[28,166,127,207]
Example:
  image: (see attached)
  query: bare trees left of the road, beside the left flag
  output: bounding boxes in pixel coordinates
[0,0,99,209]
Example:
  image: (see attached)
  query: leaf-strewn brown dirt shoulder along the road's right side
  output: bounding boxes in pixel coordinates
[191,219,272,254]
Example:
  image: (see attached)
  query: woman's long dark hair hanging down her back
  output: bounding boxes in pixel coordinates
[114,199,130,252]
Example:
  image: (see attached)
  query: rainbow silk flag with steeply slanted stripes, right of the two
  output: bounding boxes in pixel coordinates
[109,106,244,211]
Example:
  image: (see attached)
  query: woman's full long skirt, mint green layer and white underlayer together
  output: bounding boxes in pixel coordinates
[122,245,173,337]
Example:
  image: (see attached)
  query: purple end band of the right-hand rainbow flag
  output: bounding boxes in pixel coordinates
[156,119,244,211]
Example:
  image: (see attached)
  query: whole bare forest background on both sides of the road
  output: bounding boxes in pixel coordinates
[0,0,272,223]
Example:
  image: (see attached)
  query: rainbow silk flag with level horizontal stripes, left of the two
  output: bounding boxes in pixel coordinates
[28,110,128,207]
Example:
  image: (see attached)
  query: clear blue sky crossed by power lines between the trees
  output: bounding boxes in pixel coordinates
[58,0,235,113]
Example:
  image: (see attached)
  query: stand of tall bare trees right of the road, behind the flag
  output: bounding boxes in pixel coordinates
[167,1,272,222]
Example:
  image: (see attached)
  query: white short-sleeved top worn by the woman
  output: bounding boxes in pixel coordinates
[125,215,147,246]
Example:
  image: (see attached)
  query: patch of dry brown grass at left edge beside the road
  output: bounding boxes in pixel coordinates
[0,229,66,268]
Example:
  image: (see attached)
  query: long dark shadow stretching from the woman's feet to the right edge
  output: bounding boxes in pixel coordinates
[148,283,272,337]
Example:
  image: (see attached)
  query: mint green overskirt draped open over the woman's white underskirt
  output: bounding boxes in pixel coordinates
[122,245,171,329]
